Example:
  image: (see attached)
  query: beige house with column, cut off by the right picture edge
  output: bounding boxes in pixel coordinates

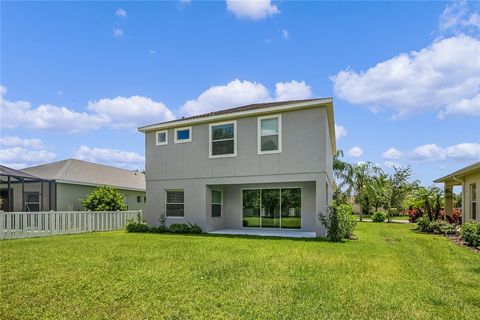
[434,162,480,222]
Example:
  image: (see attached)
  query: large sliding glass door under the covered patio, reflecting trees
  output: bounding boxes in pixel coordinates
[242,188,302,229]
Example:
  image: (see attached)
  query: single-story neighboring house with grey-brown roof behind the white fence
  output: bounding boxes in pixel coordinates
[2,159,146,211]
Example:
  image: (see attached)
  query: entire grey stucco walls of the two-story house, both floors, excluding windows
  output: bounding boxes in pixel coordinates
[144,107,333,236]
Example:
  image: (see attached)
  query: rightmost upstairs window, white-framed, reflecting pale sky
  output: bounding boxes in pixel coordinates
[258,115,282,154]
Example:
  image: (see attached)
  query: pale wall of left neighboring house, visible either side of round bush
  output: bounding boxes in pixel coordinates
[57,183,145,211]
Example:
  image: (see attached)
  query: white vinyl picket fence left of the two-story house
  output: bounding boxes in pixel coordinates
[0,210,142,239]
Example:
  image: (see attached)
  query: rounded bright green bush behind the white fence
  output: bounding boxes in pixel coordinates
[81,186,128,211]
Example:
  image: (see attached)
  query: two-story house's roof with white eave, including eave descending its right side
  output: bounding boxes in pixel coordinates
[138,98,336,154]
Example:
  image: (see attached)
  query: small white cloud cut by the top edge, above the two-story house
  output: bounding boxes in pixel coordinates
[226,0,280,20]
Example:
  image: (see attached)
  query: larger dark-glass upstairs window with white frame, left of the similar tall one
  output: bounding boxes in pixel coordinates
[209,121,237,158]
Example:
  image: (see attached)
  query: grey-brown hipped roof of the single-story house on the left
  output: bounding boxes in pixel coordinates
[22,159,145,191]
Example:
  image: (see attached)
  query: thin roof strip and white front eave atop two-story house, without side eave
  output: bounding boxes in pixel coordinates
[138,98,332,132]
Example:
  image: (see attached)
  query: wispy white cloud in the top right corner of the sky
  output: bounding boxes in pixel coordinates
[439,0,480,33]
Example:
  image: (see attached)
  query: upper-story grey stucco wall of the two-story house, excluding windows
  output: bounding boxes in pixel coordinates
[145,107,331,181]
